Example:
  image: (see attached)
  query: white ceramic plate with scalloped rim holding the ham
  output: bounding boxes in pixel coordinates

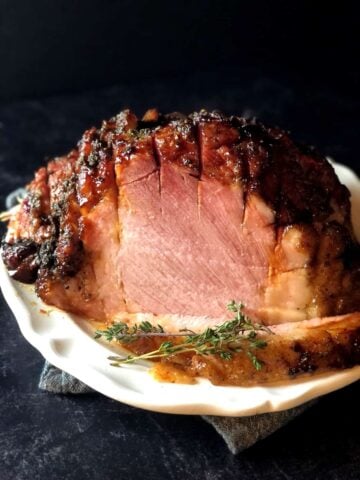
[0,165,360,416]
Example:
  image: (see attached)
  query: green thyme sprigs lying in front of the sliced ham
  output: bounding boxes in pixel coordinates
[95,300,271,370]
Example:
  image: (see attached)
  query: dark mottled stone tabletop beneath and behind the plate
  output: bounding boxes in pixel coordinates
[0,71,360,480]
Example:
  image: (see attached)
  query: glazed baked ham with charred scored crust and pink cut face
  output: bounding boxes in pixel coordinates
[2,110,360,384]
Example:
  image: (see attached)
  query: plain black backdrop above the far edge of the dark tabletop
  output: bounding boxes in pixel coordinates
[0,0,359,99]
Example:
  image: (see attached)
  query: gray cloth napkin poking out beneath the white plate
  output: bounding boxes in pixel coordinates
[39,362,314,454]
